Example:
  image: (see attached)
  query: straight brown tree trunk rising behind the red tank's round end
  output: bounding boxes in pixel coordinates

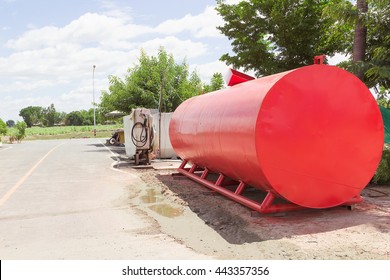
[352,0,368,80]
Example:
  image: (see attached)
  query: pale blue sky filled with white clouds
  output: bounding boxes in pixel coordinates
[0,0,346,121]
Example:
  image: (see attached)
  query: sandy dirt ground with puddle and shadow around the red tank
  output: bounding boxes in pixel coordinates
[117,158,390,260]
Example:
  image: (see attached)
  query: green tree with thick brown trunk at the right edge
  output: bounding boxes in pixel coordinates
[326,0,390,103]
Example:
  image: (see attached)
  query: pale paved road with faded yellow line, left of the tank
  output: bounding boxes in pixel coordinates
[0,139,208,260]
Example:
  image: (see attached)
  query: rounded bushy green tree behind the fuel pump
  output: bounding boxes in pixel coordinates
[100,47,202,113]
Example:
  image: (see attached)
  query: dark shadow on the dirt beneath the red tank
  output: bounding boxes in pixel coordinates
[156,174,390,244]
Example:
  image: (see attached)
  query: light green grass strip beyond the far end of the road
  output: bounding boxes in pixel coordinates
[3,124,121,140]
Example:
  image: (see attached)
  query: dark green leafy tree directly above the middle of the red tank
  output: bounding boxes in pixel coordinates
[216,0,345,76]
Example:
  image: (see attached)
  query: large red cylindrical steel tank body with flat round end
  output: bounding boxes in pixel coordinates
[169,65,384,208]
